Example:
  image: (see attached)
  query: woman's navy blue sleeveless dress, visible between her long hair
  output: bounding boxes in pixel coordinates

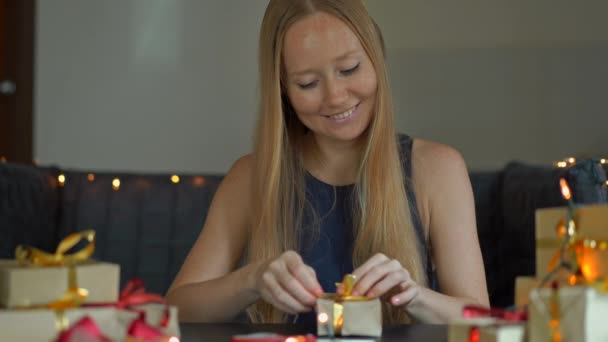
[295,135,437,323]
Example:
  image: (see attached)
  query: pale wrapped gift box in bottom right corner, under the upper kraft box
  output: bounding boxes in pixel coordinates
[528,286,608,342]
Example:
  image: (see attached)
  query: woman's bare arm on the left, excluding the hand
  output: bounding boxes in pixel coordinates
[166,156,259,322]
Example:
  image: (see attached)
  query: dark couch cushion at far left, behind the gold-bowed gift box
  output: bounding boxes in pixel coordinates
[0,163,59,258]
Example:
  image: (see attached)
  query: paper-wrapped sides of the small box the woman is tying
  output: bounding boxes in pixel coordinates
[317,298,382,336]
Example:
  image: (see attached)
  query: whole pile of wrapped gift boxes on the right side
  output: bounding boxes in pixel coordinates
[448,179,608,342]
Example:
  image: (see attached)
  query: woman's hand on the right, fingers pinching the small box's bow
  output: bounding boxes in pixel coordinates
[346,254,420,306]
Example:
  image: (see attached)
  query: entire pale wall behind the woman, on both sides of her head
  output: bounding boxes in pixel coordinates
[35,0,608,172]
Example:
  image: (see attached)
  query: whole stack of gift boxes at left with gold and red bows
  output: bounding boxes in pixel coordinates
[0,231,179,342]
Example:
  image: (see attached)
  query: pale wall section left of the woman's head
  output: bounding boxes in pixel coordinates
[35,0,266,172]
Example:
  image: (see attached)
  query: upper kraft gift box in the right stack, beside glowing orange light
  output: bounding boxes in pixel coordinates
[536,204,608,281]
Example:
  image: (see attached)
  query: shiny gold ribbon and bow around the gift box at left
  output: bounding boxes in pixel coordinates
[15,230,95,331]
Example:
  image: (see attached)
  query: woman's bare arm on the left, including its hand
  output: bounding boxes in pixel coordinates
[166,156,323,322]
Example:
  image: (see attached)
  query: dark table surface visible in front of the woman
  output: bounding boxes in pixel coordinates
[180,323,447,342]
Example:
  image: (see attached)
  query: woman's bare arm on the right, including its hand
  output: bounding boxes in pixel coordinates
[354,141,488,323]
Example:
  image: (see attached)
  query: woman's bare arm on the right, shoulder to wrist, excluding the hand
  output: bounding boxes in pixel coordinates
[407,140,489,322]
